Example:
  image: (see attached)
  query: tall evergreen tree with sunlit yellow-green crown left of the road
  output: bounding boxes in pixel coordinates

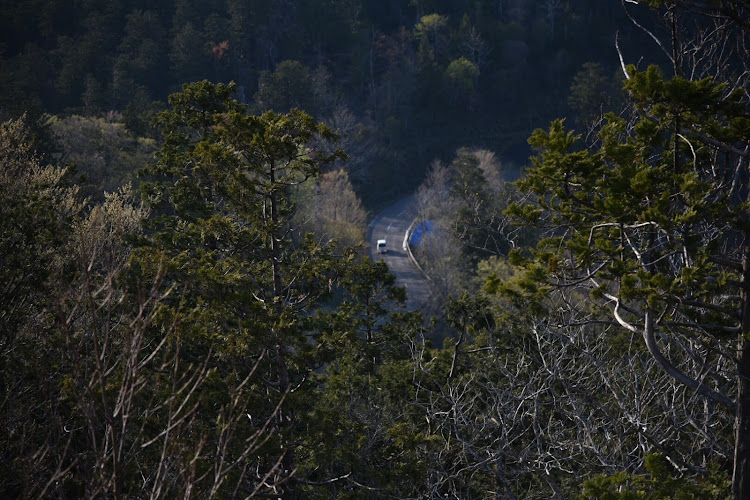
[138,81,350,497]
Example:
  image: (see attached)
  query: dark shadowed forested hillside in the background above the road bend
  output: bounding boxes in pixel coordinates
[0,0,653,204]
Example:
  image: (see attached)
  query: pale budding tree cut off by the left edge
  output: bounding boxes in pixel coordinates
[0,117,81,340]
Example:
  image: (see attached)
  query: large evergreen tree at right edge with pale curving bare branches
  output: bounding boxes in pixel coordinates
[506,61,750,492]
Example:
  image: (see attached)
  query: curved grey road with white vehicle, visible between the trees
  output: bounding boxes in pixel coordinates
[367,196,430,310]
